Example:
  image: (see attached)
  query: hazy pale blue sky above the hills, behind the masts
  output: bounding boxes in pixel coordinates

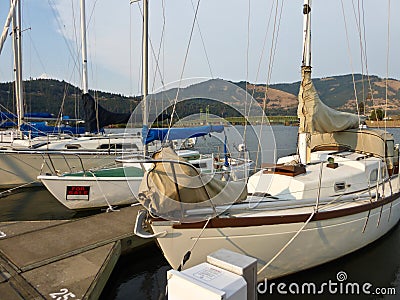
[0,0,400,95]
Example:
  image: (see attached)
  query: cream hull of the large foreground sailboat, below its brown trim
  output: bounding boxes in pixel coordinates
[151,196,400,280]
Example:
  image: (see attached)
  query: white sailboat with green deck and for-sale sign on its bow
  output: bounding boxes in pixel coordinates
[38,126,253,210]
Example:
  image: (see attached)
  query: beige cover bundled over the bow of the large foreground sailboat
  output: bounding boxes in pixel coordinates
[139,148,247,222]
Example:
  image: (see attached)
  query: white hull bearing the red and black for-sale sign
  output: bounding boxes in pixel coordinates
[38,175,142,210]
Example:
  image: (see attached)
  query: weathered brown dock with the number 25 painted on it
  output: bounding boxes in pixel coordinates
[0,205,153,300]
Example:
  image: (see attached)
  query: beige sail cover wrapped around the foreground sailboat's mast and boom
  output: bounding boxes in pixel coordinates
[297,67,359,133]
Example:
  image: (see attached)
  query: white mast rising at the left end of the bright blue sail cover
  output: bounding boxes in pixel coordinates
[142,0,149,156]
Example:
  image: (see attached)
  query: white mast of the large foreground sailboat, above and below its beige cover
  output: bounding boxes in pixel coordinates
[298,0,311,164]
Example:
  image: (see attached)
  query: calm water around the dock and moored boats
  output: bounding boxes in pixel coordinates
[0,126,400,300]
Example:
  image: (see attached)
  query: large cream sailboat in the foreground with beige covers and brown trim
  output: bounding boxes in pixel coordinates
[135,0,400,280]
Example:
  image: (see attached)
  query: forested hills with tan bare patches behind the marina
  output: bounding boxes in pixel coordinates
[0,74,400,118]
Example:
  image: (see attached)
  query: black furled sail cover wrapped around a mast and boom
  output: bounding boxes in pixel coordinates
[82,93,131,132]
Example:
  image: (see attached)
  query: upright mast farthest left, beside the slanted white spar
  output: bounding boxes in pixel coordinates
[11,0,24,137]
